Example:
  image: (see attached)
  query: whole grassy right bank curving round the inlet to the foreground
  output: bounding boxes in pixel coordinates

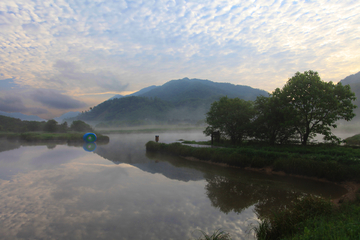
[146,142,360,240]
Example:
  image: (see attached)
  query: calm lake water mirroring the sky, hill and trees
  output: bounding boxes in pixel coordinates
[0,132,345,240]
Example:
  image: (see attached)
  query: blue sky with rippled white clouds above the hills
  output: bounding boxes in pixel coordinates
[0,0,360,119]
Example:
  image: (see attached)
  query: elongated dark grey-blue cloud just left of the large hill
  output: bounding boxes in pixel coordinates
[31,89,87,109]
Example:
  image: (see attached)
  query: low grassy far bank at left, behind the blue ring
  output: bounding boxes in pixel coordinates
[0,132,109,142]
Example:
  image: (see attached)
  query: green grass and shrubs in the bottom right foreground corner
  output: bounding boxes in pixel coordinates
[254,195,360,240]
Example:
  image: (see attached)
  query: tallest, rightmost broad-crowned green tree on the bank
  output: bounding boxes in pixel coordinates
[273,70,356,145]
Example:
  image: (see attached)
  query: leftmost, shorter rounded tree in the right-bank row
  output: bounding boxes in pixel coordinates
[204,97,255,143]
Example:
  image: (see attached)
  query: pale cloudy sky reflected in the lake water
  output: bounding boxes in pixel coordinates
[0,153,256,239]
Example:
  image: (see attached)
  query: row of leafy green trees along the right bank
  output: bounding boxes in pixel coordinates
[204,70,356,145]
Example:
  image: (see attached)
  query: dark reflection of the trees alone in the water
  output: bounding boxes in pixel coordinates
[204,174,305,217]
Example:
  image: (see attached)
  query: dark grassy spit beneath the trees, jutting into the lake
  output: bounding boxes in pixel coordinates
[146,141,360,182]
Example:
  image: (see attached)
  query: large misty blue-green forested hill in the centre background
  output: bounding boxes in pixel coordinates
[77,78,268,127]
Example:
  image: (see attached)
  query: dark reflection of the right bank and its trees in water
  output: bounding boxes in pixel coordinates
[147,152,346,217]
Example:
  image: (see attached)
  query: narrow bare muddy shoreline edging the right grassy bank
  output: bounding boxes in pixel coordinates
[180,156,360,206]
